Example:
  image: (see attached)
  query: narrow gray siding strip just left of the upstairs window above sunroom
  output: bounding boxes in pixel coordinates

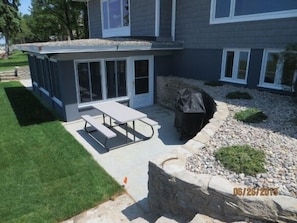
[88,0,102,39]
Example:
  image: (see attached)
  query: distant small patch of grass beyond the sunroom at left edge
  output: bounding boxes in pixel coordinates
[0,50,28,71]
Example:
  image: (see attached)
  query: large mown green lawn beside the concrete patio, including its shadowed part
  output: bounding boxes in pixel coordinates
[0,82,122,223]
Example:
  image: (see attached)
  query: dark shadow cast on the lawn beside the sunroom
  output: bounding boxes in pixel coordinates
[5,87,57,126]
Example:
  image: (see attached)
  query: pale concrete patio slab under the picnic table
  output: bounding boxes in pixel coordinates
[63,105,184,211]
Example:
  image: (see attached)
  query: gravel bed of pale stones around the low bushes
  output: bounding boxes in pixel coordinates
[186,84,297,197]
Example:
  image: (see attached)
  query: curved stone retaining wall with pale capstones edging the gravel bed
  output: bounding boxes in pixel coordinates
[148,77,297,223]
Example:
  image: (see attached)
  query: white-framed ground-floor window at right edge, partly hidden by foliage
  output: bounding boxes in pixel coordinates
[260,50,296,90]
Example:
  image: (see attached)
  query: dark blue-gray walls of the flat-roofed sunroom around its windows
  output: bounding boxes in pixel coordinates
[29,51,172,121]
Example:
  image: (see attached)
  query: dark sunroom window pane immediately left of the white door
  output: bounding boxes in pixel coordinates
[106,60,127,98]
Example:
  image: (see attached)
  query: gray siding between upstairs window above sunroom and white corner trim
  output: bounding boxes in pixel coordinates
[130,0,155,36]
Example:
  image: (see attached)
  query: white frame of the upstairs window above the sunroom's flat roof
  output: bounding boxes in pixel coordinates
[100,0,131,38]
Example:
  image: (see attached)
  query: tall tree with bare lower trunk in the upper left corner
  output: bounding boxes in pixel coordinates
[0,0,20,58]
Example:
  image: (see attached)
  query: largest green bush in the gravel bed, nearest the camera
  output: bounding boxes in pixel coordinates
[214,145,266,176]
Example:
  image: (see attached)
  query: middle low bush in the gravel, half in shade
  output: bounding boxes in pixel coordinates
[234,108,268,123]
